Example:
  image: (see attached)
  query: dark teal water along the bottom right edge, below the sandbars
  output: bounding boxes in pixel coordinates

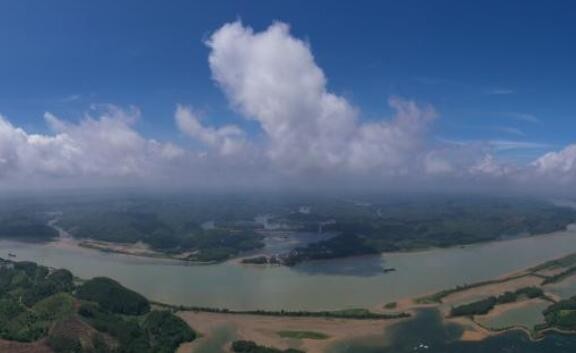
[329,309,576,353]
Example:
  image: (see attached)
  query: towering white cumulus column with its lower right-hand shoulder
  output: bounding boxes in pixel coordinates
[207,22,436,174]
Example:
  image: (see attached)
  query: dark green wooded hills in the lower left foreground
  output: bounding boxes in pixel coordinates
[0,259,196,353]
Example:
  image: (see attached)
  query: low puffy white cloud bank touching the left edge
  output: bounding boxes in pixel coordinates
[0,106,184,183]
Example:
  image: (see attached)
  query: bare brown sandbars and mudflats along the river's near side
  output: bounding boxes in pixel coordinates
[172,250,576,353]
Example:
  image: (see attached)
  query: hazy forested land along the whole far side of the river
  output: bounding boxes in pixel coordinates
[0,195,576,270]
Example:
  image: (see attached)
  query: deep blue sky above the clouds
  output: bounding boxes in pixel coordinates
[0,0,576,188]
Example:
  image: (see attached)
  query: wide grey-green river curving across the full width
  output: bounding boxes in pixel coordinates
[0,231,576,310]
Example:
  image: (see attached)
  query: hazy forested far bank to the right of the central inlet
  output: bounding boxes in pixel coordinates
[283,197,576,264]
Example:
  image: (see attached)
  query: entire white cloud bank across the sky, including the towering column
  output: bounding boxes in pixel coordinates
[0,21,576,190]
